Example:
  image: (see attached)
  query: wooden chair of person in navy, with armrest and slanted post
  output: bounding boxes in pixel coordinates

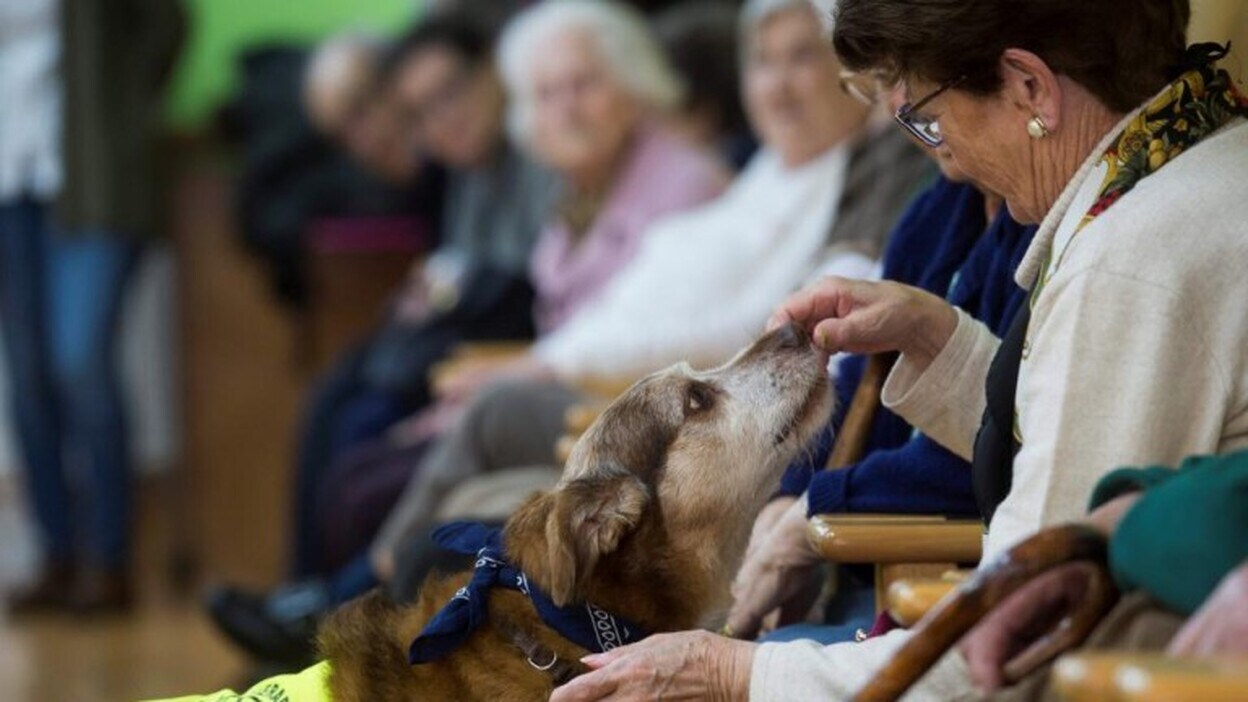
[806,353,983,611]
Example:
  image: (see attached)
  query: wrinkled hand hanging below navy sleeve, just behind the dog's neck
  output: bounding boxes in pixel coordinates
[728,498,821,638]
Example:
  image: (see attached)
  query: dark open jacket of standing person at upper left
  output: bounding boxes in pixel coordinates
[56,0,185,237]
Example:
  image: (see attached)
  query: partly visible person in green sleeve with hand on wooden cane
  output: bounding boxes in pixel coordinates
[960,451,1248,700]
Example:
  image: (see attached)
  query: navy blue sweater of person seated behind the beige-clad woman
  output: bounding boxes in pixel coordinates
[780,179,1036,516]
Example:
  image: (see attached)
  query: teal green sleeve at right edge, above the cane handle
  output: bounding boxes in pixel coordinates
[1091,451,1248,615]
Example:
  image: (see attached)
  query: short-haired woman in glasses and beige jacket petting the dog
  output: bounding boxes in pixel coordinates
[553,0,1248,702]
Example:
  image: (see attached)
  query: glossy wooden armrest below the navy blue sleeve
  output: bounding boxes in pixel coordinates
[806,515,983,563]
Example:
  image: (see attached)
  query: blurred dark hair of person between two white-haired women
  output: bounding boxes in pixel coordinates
[654,0,750,134]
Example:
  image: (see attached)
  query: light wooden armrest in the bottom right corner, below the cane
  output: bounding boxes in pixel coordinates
[1052,652,1248,702]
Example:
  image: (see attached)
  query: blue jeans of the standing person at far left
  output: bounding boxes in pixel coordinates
[0,199,141,568]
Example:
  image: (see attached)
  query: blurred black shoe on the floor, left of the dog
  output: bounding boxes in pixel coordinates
[206,582,329,666]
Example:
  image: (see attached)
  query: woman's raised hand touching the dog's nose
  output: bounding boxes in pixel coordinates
[768,277,957,368]
